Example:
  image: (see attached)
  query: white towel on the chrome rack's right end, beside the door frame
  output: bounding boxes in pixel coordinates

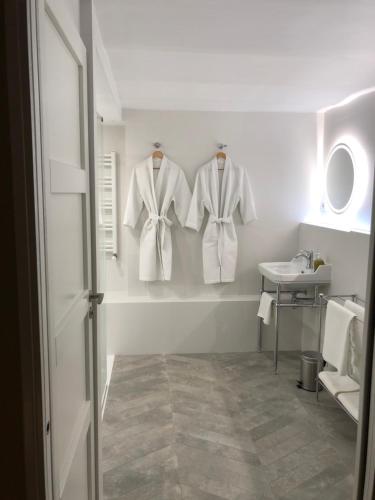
[345,300,365,383]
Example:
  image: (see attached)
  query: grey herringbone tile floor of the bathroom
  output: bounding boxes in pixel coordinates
[103,353,356,500]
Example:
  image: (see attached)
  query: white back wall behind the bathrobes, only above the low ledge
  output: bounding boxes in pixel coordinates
[104,111,315,298]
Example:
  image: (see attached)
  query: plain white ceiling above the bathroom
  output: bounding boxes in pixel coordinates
[95,0,375,111]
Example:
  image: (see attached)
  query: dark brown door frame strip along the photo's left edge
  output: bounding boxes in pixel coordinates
[0,0,46,500]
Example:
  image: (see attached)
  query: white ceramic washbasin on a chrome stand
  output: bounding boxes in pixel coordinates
[258,261,332,285]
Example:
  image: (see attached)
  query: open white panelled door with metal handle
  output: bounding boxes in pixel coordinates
[39,0,95,500]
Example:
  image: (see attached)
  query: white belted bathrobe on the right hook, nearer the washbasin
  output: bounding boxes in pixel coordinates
[186,156,256,284]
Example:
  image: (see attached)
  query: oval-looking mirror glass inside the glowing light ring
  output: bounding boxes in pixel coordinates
[326,144,354,213]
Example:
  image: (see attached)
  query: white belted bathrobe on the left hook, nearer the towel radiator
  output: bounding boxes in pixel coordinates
[124,156,191,281]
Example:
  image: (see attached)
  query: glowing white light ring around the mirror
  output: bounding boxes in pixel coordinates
[324,135,369,216]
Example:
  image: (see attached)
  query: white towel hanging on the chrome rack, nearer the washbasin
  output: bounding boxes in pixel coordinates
[322,300,355,375]
